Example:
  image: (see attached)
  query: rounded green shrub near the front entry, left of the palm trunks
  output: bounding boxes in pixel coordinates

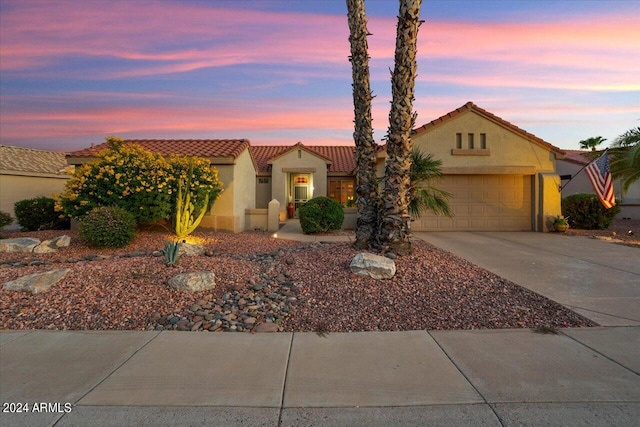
[298,197,344,234]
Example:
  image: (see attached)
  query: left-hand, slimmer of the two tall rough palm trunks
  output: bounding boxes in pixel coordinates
[347,0,379,249]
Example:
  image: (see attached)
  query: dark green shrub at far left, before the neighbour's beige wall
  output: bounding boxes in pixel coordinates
[13,197,69,231]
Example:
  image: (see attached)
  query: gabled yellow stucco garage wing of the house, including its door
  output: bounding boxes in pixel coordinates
[412,102,564,231]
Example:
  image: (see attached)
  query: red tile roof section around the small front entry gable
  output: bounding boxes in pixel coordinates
[250,143,356,173]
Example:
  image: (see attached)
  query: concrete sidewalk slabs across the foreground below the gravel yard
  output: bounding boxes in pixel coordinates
[0,327,640,426]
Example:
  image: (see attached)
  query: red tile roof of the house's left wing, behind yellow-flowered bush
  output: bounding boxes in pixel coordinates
[68,139,249,159]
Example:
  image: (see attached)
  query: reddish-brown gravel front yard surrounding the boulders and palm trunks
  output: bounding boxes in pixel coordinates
[0,231,595,333]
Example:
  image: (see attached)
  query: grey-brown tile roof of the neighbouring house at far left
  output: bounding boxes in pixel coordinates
[0,145,69,176]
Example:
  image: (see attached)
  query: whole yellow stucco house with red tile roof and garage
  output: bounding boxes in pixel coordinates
[67,103,563,232]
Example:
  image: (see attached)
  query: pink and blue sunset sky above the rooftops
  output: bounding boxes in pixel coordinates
[0,0,640,151]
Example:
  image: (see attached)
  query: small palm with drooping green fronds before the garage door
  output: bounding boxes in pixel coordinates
[409,150,453,218]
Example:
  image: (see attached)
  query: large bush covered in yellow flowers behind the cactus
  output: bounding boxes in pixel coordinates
[56,137,222,231]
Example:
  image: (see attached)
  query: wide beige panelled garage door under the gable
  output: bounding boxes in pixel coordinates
[412,175,533,231]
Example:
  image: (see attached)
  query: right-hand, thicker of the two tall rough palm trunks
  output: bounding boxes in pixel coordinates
[378,0,422,255]
